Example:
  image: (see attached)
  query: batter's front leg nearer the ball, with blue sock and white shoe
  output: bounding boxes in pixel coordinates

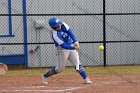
[69,50,92,84]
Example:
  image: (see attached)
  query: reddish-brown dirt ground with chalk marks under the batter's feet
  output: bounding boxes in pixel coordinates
[0,75,140,93]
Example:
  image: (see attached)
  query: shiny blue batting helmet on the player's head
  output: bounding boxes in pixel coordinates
[48,17,62,28]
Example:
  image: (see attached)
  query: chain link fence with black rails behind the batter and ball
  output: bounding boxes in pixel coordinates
[0,0,140,67]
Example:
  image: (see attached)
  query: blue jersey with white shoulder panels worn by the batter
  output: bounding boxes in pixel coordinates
[52,22,77,49]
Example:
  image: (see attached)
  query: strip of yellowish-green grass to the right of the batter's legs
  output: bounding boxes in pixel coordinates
[89,66,140,75]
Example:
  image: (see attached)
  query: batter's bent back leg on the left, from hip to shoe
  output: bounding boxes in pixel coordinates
[43,48,69,84]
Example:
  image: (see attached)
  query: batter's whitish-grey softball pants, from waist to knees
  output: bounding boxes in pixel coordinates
[56,47,80,72]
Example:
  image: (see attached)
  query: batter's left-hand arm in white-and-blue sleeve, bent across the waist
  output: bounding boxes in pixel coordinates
[53,32,75,49]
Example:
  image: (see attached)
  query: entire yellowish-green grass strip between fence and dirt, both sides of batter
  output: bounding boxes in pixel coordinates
[4,66,140,76]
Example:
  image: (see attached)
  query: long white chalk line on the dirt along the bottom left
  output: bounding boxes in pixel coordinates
[1,86,84,92]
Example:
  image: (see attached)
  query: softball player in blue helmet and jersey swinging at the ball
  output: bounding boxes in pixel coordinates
[42,17,92,84]
